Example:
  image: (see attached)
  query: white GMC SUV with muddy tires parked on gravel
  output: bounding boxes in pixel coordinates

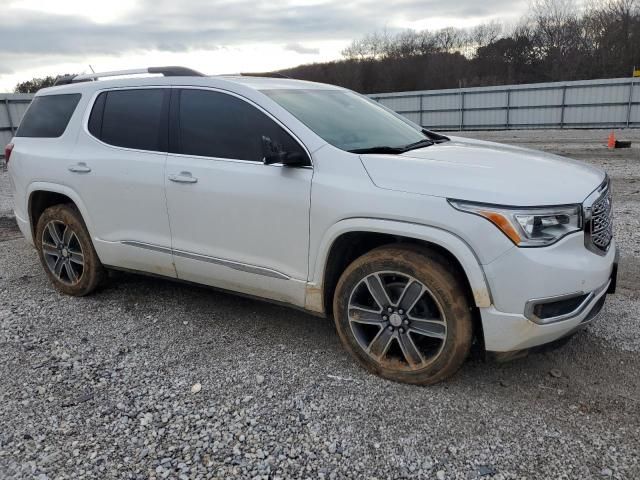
[6,67,617,384]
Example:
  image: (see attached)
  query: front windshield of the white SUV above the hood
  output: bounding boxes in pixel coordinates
[263,89,427,151]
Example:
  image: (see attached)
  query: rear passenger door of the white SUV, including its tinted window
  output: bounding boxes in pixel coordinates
[72,87,175,277]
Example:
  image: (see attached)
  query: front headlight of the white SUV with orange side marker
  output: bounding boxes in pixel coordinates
[449,200,582,247]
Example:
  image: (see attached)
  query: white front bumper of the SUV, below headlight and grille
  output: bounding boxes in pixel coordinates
[480,235,618,356]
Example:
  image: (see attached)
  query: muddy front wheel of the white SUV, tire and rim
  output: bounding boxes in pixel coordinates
[333,245,473,385]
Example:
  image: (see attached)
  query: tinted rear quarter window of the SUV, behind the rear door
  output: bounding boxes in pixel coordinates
[16,93,81,138]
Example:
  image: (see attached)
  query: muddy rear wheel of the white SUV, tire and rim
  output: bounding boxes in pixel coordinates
[35,205,105,297]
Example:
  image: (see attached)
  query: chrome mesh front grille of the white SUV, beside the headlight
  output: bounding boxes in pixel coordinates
[583,177,613,255]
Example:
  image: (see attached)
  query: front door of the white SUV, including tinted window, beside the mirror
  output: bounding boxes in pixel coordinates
[166,88,313,305]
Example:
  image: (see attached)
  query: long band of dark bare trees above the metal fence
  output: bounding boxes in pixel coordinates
[279,0,640,93]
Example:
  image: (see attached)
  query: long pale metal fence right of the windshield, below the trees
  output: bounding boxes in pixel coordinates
[370,78,640,130]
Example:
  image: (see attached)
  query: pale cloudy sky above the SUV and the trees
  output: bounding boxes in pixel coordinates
[0,0,527,92]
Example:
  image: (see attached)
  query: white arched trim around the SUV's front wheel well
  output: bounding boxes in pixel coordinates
[305,218,491,313]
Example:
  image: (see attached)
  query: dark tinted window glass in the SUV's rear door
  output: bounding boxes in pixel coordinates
[88,88,169,152]
